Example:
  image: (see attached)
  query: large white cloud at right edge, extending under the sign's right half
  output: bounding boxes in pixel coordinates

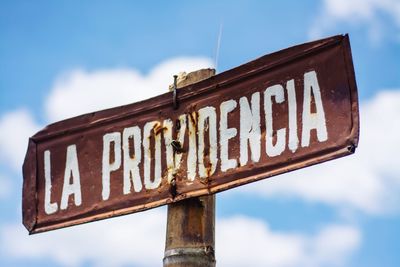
[238,90,400,214]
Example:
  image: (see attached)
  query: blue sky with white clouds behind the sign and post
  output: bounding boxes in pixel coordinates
[0,0,400,267]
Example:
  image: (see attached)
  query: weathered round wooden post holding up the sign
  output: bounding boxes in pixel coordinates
[163,69,215,267]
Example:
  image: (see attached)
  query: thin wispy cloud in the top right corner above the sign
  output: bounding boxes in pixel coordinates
[309,0,400,42]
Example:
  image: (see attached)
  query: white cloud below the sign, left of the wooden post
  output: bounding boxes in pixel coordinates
[0,209,166,266]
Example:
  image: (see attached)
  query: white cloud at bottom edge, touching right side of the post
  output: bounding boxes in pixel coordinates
[216,216,361,267]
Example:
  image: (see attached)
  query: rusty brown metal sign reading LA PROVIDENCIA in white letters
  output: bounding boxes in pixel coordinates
[22,35,359,233]
